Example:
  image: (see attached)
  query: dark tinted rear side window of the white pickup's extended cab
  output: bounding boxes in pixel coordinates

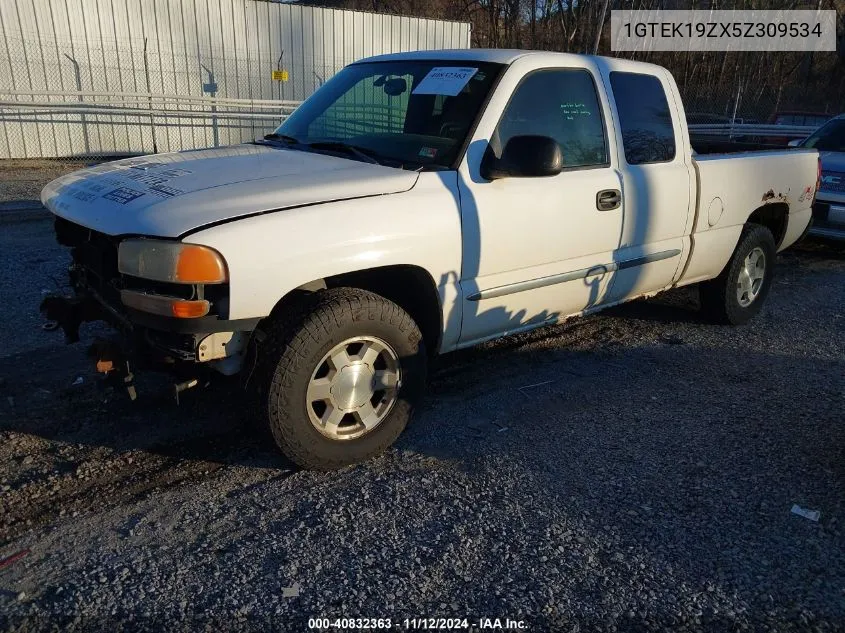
[610,72,675,165]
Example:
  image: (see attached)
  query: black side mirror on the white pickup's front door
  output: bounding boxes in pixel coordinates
[481,136,563,180]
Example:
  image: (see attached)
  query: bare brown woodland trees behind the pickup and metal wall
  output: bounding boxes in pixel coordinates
[296,0,845,120]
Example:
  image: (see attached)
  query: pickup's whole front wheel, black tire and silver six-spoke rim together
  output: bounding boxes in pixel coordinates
[249,288,426,470]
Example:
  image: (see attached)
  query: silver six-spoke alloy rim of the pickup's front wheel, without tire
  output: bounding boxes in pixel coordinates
[306,336,402,440]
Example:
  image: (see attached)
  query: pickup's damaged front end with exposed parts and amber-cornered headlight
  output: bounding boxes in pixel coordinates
[40,217,257,398]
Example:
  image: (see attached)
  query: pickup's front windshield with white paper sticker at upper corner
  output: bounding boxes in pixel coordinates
[271,60,502,168]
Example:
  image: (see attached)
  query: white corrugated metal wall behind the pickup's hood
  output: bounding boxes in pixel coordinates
[0,0,470,158]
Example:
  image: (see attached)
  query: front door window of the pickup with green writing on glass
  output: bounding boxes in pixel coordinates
[490,69,609,167]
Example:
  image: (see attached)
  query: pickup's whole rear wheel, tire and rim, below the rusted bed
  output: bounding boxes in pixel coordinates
[701,224,776,325]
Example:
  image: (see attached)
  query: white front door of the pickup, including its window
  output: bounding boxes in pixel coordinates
[459,60,624,346]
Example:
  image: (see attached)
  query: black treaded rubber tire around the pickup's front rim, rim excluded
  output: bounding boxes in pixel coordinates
[248,288,427,470]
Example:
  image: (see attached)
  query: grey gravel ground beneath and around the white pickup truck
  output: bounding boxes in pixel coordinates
[0,222,845,631]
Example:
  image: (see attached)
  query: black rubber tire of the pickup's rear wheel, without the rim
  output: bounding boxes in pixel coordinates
[700,224,776,325]
